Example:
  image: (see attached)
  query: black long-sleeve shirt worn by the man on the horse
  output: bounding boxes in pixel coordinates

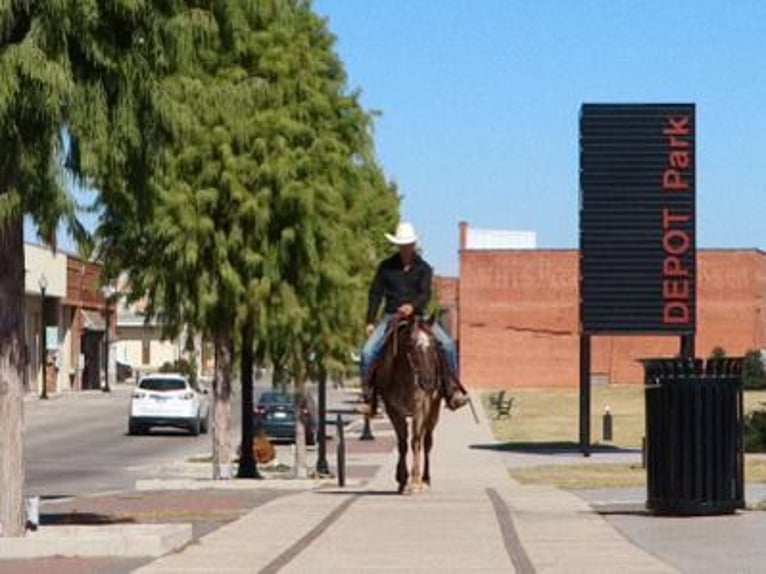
[367,253,433,324]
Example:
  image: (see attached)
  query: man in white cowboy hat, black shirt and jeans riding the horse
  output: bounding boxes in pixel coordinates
[360,222,468,414]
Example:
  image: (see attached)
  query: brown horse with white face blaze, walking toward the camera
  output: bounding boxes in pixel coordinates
[373,317,444,494]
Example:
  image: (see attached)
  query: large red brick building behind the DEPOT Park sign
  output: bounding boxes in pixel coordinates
[456,228,766,389]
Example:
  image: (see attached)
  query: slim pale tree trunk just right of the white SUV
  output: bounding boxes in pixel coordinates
[213,328,234,480]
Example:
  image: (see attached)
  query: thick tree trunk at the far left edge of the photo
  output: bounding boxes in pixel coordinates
[0,216,25,537]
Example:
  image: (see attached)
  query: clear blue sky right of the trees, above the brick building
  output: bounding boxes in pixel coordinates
[314,0,766,275]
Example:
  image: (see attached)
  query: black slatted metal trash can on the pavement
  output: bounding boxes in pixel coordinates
[641,358,745,516]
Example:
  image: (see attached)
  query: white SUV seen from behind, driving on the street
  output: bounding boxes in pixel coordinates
[128,373,210,436]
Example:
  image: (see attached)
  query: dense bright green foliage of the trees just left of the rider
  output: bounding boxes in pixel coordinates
[85,0,398,392]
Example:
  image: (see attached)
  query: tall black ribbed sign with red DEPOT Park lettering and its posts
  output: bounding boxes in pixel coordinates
[579,104,697,454]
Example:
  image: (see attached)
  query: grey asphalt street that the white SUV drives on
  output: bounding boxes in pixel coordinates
[24,385,232,497]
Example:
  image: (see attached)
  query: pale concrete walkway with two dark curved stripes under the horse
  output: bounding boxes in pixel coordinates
[137,409,674,574]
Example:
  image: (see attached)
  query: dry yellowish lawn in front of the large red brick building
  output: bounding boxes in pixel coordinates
[482,385,766,448]
